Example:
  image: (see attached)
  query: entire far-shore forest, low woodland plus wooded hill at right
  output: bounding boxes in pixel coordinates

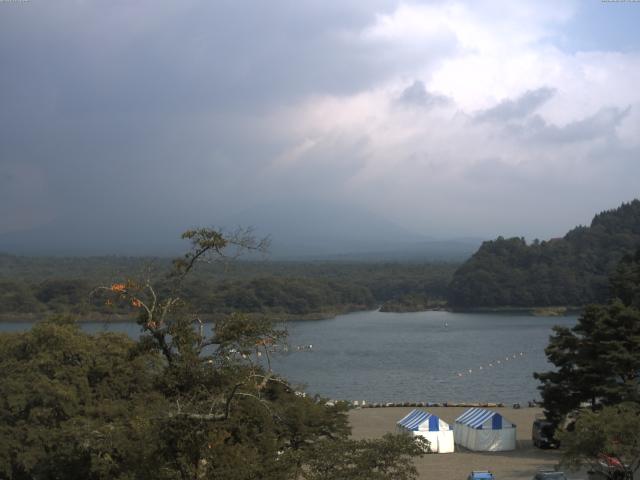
[5,200,640,320]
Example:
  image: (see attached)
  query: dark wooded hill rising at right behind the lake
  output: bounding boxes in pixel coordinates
[449,200,640,307]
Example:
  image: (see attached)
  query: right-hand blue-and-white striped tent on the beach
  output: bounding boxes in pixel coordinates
[453,408,516,452]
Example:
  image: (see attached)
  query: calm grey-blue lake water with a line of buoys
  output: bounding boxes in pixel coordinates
[0,311,577,403]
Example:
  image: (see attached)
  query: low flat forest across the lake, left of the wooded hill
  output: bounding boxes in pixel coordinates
[0,256,456,317]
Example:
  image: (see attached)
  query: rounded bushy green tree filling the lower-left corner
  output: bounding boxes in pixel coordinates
[0,318,164,479]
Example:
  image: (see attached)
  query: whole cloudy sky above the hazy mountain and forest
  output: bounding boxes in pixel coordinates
[0,0,640,253]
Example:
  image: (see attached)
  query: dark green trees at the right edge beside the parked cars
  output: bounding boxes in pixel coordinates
[535,250,640,478]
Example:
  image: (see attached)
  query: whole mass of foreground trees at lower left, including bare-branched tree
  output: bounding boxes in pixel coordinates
[0,229,428,480]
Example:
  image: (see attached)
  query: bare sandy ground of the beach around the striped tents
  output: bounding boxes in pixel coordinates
[349,407,586,480]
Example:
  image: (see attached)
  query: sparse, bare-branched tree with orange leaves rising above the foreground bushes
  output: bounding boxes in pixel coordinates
[92,228,286,420]
